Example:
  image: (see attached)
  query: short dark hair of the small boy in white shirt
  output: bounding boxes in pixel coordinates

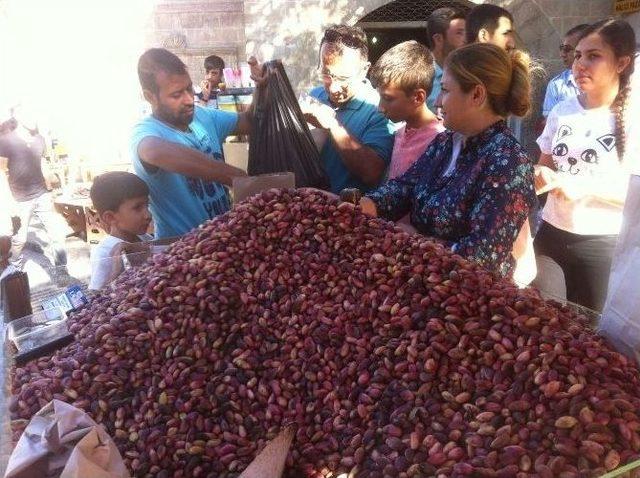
[89,171,149,214]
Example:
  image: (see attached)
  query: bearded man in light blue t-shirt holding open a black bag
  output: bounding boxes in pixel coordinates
[130,48,251,239]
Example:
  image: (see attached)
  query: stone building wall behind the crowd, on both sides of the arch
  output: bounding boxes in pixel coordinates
[148,0,640,154]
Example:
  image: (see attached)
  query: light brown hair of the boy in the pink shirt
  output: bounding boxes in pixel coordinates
[369,40,435,96]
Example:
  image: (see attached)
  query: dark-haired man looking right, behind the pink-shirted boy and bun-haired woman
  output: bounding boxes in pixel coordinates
[427,7,466,114]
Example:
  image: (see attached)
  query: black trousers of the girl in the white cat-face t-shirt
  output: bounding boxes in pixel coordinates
[533,222,618,312]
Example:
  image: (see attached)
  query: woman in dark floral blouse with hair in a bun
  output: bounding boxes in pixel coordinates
[348,44,536,276]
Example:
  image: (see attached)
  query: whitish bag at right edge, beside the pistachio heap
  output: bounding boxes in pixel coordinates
[599,176,640,363]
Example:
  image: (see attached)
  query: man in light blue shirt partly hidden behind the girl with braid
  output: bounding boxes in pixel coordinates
[542,24,589,118]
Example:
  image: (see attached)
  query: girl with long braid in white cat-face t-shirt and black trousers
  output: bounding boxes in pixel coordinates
[534,19,635,311]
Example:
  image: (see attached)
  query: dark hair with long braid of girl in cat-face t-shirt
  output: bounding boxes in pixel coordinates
[580,18,636,161]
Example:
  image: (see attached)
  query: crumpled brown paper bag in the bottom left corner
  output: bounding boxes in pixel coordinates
[5,400,130,478]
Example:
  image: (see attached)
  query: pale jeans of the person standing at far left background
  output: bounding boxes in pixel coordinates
[11,193,67,267]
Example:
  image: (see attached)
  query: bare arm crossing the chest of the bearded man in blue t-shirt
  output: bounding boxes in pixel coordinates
[138,136,247,187]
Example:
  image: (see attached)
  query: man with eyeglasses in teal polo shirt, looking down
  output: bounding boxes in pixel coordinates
[303,25,394,193]
